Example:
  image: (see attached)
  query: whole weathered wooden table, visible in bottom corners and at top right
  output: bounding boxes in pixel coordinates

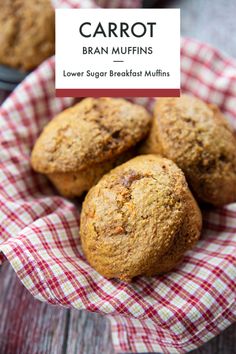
[0,0,236,354]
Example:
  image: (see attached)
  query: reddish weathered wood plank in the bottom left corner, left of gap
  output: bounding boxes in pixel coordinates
[0,264,68,354]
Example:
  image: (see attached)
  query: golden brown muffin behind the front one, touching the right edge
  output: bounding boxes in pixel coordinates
[141,95,236,205]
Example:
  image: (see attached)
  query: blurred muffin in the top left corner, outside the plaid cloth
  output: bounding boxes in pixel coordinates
[0,0,55,71]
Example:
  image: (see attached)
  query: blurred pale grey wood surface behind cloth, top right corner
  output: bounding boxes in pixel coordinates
[143,0,236,58]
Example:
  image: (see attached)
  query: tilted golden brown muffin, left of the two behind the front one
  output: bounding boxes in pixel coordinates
[31,98,151,197]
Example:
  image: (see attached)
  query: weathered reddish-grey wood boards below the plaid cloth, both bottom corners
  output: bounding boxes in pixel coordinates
[0,263,236,354]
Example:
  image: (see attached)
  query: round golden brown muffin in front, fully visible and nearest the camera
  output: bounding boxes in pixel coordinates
[80,155,202,282]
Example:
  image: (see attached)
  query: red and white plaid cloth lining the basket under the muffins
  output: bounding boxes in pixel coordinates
[0,1,236,353]
